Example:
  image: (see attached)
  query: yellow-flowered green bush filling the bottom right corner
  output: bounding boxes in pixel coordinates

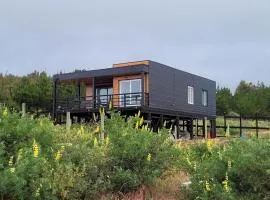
[181,139,270,199]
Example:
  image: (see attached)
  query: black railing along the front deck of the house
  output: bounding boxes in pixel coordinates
[55,92,149,112]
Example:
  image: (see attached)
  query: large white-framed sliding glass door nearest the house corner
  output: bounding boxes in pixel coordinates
[119,79,142,107]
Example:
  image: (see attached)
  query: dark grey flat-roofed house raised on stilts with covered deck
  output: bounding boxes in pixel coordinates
[53,60,216,137]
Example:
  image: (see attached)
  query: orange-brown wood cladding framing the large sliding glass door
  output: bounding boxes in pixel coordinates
[113,74,149,107]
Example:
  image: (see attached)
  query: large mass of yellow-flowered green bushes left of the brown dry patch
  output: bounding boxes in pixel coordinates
[0,109,180,199]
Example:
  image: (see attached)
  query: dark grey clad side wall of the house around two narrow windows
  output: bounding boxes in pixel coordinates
[149,61,216,117]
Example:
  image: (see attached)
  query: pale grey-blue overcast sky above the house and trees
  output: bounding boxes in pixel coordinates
[0,0,270,89]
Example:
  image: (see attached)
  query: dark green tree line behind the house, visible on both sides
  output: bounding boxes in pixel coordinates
[0,71,270,115]
